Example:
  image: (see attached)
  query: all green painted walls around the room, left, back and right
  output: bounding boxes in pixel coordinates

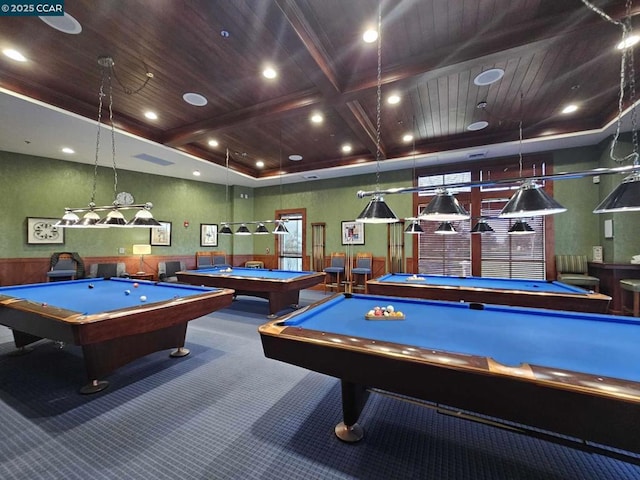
[0,143,640,263]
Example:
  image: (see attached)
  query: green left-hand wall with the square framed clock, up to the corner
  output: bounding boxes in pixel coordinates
[0,152,226,258]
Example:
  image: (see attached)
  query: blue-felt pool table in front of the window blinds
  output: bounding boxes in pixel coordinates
[367,273,611,313]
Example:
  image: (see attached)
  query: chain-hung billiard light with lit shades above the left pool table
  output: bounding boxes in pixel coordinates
[55,56,160,228]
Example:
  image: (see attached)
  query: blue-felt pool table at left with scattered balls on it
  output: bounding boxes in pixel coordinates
[0,277,233,394]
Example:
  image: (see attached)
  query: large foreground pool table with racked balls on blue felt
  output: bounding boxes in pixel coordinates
[259,293,640,453]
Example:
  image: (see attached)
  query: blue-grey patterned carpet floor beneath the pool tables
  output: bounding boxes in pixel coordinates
[0,291,640,480]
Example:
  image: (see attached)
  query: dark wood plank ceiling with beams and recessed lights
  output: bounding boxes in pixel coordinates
[0,0,637,178]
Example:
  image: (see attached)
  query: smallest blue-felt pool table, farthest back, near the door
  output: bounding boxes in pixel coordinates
[176,267,325,318]
